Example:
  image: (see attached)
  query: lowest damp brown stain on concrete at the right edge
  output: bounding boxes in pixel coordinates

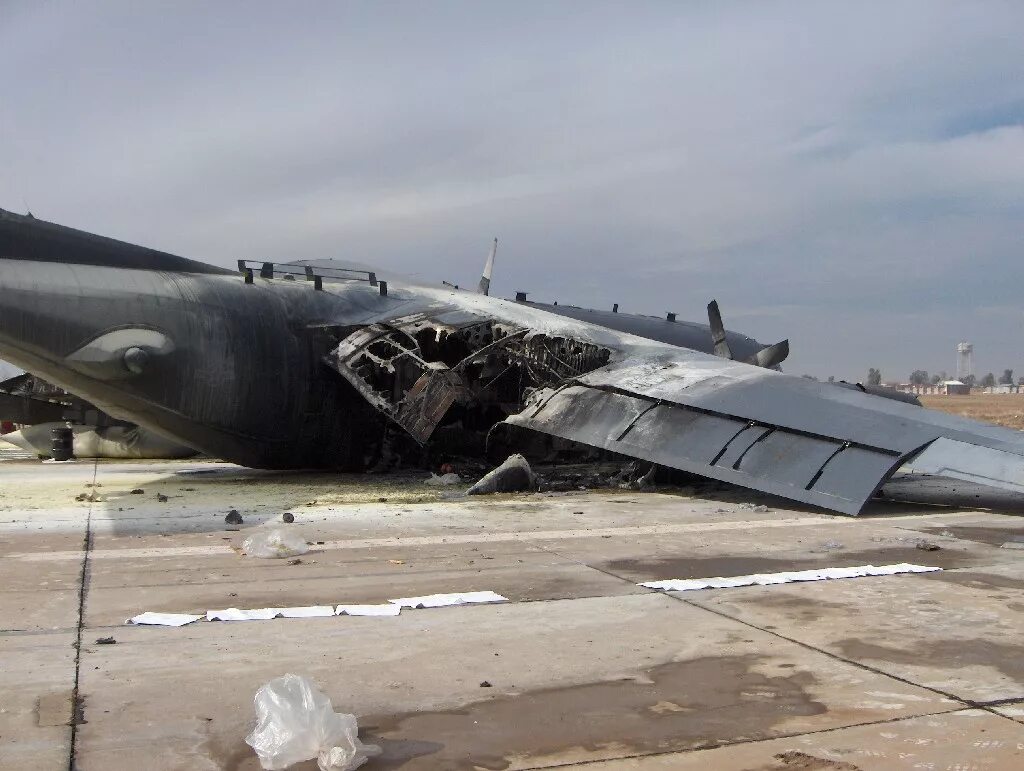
[836,638,1024,685]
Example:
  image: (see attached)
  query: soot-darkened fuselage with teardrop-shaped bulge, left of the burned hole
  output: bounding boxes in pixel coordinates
[0,207,387,468]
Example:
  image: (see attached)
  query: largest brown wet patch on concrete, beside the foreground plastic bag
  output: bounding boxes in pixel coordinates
[359,655,826,771]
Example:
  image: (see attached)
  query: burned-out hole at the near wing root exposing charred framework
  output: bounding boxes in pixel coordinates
[325,313,610,443]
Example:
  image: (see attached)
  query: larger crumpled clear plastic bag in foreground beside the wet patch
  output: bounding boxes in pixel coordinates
[246,675,381,771]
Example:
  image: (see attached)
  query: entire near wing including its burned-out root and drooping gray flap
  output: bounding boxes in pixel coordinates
[296,262,1024,514]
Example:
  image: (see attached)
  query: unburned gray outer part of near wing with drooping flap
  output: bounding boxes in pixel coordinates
[505,352,1024,514]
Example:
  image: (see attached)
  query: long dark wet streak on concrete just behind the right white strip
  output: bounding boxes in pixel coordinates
[594,546,962,583]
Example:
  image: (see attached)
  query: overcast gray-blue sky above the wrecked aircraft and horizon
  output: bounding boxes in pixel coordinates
[0,0,1024,380]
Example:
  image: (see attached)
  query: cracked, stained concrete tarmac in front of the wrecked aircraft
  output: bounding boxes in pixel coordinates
[0,462,1024,771]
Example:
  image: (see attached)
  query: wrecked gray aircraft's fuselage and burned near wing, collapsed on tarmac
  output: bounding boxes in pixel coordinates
[0,210,1024,514]
